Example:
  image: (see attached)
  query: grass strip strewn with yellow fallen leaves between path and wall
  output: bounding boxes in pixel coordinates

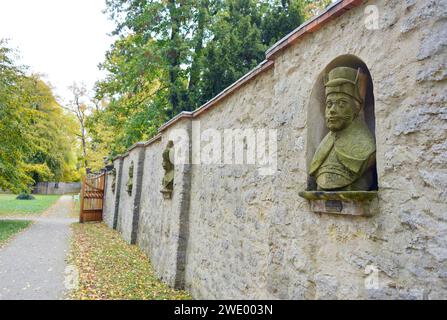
[69,223,191,300]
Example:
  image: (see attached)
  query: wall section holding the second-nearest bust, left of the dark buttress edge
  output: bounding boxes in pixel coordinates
[137,123,190,287]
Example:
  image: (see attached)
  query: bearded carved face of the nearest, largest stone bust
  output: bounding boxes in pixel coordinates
[325,92,358,131]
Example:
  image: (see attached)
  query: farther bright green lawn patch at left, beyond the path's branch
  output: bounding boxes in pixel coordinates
[0,194,60,216]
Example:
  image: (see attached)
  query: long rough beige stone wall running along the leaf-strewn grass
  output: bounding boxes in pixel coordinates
[105,0,447,299]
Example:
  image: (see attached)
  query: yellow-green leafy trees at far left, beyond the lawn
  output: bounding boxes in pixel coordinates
[0,41,80,192]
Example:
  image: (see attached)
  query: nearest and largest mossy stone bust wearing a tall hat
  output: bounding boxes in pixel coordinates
[309,67,376,191]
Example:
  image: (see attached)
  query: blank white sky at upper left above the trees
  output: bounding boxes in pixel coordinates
[0,0,114,102]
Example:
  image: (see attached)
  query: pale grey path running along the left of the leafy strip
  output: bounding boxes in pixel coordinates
[0,196,77,300]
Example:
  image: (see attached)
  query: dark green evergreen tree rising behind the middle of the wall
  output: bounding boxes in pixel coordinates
[199,0,267,103]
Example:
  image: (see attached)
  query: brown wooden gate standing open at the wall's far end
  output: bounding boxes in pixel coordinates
[79,173,106,223]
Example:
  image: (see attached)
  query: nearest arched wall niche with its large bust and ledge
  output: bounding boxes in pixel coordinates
[300,55,378,214]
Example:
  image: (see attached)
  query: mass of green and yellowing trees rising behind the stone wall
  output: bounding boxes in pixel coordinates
[87,0,330,159]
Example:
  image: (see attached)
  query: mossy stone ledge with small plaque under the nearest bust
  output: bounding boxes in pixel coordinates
[299,191,377,216]
